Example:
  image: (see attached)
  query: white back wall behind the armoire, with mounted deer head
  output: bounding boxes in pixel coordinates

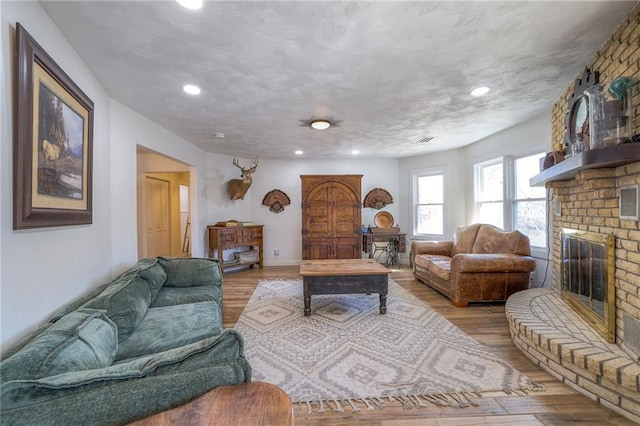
[207,158,400,266]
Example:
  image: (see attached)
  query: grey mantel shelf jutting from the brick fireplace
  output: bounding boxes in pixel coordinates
[529,142,640,186]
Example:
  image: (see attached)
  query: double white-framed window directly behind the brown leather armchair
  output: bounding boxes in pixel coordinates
[475,153,547,248]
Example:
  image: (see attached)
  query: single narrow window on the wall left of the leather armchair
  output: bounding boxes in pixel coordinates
[413,170,444,236]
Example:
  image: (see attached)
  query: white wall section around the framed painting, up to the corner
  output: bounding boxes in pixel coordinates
[0,1,112,345]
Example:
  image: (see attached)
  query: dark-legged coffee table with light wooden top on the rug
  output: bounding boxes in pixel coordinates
[300,259,391,317]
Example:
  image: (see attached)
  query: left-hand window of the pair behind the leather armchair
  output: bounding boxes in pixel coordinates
[475,158,504,228]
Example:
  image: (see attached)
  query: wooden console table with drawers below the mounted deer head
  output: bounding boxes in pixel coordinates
[207,225,264,271]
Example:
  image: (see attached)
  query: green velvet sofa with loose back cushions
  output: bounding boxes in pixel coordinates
[0,257,251,425]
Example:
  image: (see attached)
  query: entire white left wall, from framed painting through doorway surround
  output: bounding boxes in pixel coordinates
[0,1,210,347]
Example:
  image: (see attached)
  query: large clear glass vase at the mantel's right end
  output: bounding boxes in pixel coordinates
[584,77,634,149]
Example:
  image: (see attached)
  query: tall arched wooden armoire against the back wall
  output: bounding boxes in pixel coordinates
[300,175,362,259]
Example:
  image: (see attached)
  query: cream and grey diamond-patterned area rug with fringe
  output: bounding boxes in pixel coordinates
[235,280,543,412]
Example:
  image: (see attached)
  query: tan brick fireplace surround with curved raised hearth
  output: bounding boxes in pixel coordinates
[505,3,640,423]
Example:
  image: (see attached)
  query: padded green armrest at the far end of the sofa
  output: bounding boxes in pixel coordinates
[158,257,222,287]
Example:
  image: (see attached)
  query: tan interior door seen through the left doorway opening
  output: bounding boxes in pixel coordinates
[145,177,171,257]
